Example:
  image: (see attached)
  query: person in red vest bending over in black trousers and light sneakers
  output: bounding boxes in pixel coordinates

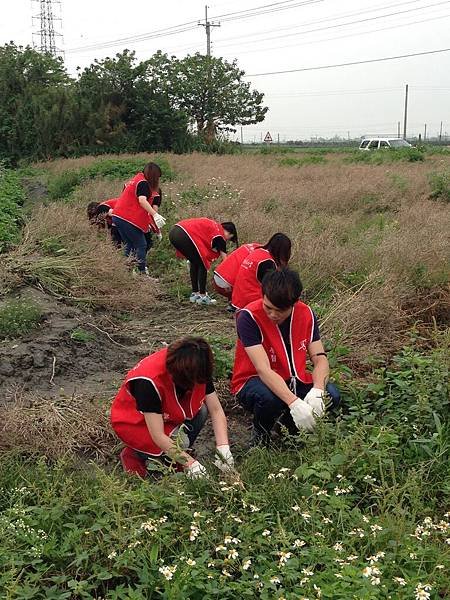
[169,217,238,305]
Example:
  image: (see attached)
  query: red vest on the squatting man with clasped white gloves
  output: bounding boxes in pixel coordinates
[231,298,314,394]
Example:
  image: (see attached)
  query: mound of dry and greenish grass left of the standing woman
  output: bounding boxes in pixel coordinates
[0,203,156,310]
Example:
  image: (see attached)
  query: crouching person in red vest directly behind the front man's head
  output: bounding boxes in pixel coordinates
[231,233,291,310]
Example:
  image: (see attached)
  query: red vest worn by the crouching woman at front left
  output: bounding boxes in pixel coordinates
[111,348,206,456]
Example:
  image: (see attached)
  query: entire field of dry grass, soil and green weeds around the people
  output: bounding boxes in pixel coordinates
[0,151,450,600]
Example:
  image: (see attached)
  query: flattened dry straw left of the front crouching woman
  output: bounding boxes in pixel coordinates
[0,393,117,459]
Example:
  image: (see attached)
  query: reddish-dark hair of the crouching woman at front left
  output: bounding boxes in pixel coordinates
[166,337,214,390]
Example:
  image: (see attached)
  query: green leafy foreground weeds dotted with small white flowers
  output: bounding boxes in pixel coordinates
[0,340,450,600]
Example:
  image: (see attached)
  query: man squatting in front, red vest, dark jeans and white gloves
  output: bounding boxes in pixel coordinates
[231,268,340,444]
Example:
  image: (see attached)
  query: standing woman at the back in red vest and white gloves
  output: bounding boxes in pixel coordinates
[112,162,166,275]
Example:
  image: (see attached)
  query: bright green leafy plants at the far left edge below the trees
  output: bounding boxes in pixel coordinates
[0,165,25,253]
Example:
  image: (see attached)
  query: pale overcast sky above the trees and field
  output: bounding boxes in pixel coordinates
[0,0,450,141]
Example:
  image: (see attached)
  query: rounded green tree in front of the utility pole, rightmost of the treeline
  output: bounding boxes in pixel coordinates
[162,54,268,141]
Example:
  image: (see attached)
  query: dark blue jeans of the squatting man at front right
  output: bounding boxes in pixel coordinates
[237,377,341,440]
